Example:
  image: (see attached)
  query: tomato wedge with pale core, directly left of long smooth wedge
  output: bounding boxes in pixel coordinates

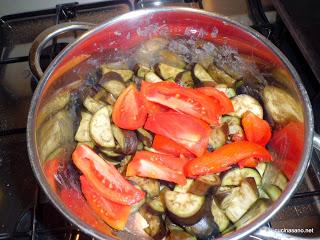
[126,151,189,185]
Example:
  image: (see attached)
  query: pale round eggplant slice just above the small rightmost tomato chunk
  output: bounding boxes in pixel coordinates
[229,94,263,119]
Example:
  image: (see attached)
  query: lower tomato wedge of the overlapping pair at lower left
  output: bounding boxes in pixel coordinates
[80,176,131,230]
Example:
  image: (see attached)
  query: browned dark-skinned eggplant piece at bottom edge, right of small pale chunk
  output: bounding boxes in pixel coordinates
[139,207,167,240]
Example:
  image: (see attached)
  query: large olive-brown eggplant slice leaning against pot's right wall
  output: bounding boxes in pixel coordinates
[263,86,303,124]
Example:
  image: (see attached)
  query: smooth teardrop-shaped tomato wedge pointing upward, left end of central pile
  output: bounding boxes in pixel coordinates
[112,85,147,130]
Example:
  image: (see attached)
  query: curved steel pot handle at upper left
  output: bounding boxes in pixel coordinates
[29,22,96,80]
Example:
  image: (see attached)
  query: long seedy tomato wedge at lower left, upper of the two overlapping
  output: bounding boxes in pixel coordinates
[72,144,145,205]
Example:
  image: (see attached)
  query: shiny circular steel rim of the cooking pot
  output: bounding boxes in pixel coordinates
[27,7,314,239]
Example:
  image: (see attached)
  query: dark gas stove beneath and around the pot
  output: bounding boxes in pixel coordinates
[0,0,320,239]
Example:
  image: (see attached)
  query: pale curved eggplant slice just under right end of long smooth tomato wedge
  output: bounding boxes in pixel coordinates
[221,168,261,186]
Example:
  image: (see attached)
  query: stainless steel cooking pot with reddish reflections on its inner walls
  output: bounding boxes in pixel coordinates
[27,8,320,239]
